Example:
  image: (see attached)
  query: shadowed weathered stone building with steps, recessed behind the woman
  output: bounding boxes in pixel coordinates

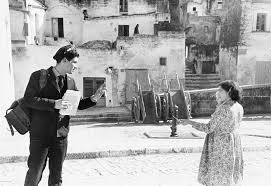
[185,0,221,89]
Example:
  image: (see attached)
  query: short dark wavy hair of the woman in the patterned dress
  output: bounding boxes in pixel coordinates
[218,80,242,102]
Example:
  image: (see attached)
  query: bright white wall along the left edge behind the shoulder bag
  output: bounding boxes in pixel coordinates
[0,0,14,136]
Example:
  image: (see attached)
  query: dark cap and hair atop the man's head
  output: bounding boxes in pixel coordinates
[53,45,79,63]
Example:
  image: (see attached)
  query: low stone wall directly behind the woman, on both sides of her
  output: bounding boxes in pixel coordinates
[186,84,271,117]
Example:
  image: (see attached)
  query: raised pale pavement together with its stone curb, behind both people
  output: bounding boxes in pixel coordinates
[0,116,271,163]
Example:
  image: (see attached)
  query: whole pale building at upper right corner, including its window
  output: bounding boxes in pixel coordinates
[237,0,271,85]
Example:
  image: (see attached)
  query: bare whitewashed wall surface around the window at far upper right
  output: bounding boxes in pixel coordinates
[237,3,271,85]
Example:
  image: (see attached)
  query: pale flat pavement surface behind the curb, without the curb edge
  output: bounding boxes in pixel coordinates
[0,119,271,162]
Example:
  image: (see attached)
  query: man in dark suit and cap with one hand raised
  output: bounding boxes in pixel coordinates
[24,45,104,186]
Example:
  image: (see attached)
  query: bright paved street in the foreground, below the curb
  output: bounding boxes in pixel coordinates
[0,151,271,186]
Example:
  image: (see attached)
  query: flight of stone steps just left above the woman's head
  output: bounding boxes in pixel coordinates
[185,71,220,90]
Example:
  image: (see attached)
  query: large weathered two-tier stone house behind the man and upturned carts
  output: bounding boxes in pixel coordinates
[13,0,185,107]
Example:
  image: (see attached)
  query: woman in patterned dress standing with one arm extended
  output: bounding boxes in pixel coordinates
[180,80,244,186]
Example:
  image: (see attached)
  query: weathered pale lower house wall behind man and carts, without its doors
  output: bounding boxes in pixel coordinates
[13,32,185,106]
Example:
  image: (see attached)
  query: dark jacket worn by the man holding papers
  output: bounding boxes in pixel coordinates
[24,67,96,143]
